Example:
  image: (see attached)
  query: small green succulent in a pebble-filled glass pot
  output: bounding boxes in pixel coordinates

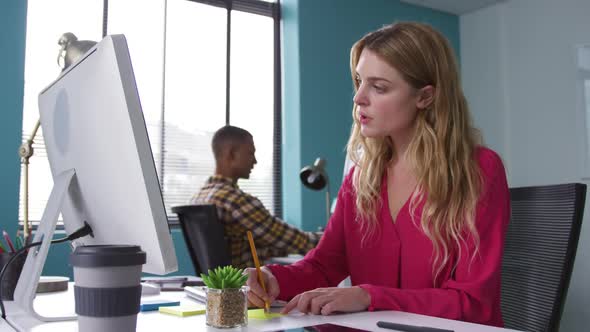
[201,265,248,328]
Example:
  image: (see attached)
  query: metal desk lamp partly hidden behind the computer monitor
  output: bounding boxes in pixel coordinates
[18,32,96,240]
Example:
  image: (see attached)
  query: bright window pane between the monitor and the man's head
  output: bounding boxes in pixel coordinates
[162,0,227,210]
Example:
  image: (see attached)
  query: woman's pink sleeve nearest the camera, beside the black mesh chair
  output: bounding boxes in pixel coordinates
[359,154,510,325]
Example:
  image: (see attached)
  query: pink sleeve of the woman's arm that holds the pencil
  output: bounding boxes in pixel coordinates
[268,171,352,300]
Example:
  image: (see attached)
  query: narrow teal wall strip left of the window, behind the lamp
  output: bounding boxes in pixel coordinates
[0,0,27,240]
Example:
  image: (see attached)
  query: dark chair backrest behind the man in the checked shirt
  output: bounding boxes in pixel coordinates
[172,205,231,276]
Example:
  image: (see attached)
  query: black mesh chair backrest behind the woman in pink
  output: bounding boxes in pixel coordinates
[501,183,586,331]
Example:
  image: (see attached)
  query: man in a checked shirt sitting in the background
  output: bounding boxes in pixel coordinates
[191,126,320,268]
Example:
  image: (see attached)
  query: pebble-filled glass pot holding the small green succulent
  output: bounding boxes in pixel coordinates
[205,286,249,328]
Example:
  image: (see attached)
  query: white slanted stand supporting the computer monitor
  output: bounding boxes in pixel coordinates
[5,169,77,331]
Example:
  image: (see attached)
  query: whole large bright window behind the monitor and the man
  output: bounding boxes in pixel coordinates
[20,0,281,226]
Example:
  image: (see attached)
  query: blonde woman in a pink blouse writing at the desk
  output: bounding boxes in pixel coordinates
[248,22,510,326]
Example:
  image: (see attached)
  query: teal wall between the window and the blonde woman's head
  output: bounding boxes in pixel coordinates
[282,0,459,230]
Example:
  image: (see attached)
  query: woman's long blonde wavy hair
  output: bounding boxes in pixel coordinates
[347,22,482,284]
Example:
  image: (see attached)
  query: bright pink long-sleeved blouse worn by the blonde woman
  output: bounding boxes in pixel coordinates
[269,147,510,326]
